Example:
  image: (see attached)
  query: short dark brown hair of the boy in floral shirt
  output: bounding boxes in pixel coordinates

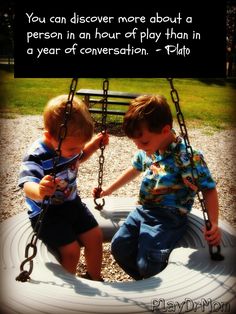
[123,95,173,138]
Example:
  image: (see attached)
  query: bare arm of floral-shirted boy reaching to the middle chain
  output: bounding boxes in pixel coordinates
[93,167,140,197]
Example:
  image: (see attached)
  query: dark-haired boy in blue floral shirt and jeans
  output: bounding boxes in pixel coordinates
[94,96,220,280]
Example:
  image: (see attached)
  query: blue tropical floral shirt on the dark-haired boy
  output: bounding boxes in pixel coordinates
[132,137,215,212]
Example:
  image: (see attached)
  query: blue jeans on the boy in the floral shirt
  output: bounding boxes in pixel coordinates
[111,206,187,280]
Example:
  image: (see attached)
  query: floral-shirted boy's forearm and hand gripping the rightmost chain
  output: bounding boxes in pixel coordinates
[202,188,221,246]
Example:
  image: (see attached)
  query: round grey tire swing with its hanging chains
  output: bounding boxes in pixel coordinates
[0,79,236,314]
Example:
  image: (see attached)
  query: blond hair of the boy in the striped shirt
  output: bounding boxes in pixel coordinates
[43,95,94,142]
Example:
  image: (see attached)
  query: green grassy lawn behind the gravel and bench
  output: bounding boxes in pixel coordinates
[0,70,236,129]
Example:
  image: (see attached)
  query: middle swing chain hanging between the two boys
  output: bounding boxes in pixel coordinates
[94,79,109,211]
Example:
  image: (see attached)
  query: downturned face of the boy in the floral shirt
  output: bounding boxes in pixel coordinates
[132,126,170,155]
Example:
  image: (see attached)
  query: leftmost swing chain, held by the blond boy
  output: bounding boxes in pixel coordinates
[16,78,78,282]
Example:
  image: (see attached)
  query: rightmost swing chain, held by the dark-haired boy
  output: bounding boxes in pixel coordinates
[167,78,224,261]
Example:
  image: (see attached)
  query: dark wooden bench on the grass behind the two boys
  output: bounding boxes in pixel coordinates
[76,89,141,115]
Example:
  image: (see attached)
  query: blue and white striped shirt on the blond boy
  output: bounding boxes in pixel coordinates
[18,140,82,218]
